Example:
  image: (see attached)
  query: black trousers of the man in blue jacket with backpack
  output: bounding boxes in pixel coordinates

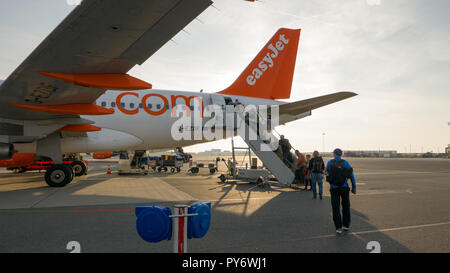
[330,187,350,229]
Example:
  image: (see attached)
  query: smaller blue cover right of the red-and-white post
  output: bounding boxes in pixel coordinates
[187,202,211,239]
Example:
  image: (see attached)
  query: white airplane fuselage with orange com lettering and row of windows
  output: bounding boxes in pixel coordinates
[50,90,282,153]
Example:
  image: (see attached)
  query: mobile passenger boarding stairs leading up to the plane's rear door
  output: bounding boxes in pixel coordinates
[237,111,297,186]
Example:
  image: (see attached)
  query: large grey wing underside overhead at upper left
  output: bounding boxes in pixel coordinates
[0,0,212,120]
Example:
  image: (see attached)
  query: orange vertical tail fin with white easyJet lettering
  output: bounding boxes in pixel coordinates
[219,28,301,99]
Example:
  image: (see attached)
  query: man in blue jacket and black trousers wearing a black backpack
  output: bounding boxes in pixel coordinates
[326,149,356,234]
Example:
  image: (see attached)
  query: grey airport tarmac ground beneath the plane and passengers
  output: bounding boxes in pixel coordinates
[0,158,450,253]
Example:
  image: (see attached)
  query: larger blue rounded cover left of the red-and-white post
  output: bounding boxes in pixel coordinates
[135,206,172,243]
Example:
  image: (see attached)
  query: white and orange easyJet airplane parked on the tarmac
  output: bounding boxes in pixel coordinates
[0,0,357,187]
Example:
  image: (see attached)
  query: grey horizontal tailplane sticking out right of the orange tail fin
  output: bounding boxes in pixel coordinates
[280,92,358,124]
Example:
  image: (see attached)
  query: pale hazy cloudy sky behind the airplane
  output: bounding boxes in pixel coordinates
[0,0,450,153]
